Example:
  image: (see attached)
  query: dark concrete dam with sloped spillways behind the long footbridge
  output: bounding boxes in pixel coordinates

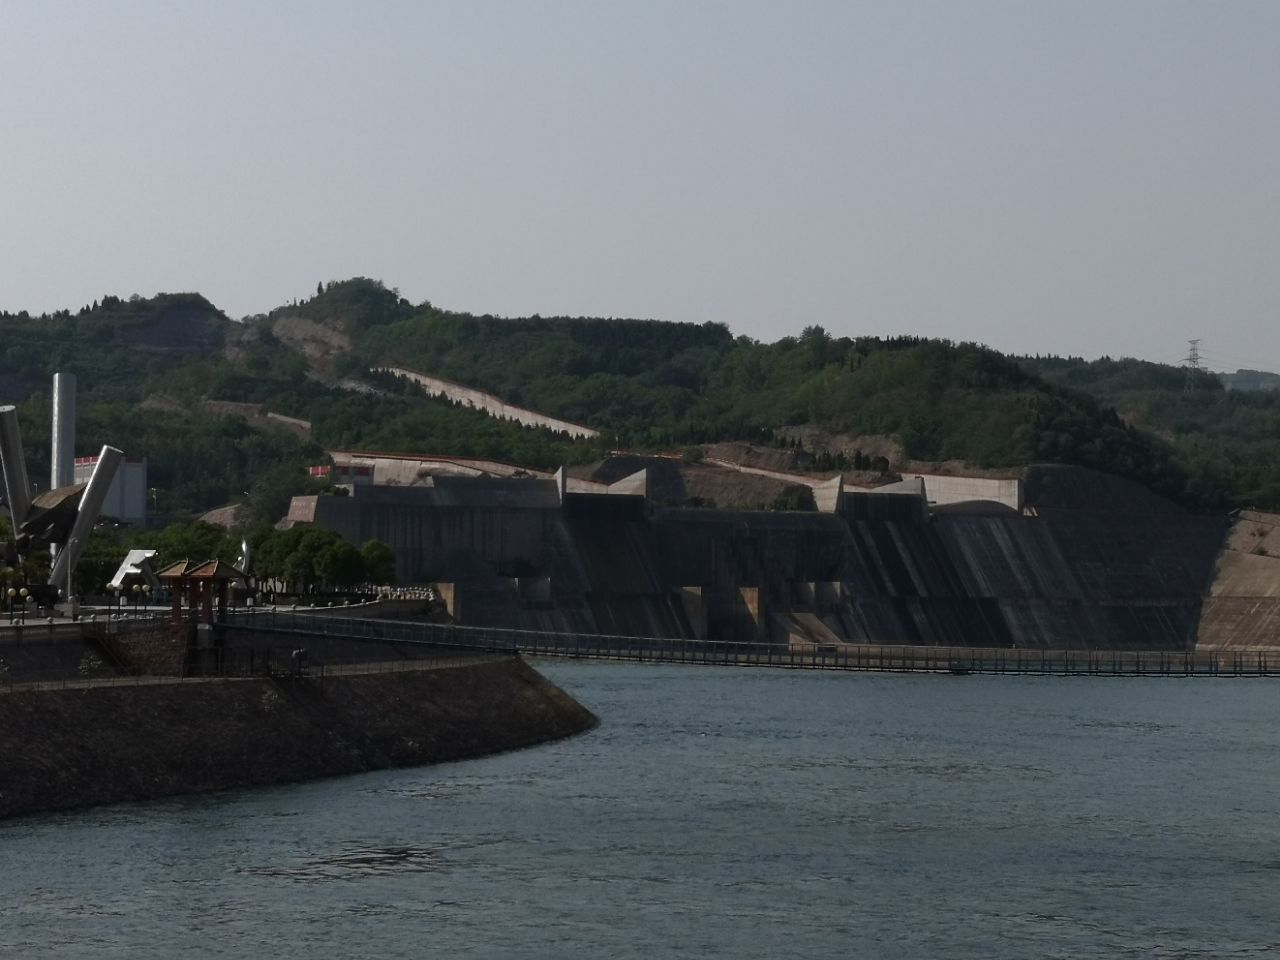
[291,466,1229,650]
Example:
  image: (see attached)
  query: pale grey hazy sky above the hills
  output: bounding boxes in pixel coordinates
[0,0,1280,370]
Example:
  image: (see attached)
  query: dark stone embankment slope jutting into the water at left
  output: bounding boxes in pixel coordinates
[0,658,595,817]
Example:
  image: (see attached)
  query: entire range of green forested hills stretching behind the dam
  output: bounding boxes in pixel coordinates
[0,279,1280,518]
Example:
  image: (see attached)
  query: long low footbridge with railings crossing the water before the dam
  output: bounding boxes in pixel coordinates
[223,609,1280,677]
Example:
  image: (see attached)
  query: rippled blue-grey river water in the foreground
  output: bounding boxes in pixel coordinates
[0,662,1280,960]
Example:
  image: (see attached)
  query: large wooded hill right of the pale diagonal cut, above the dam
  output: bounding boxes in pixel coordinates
[326,284,1187,500]
